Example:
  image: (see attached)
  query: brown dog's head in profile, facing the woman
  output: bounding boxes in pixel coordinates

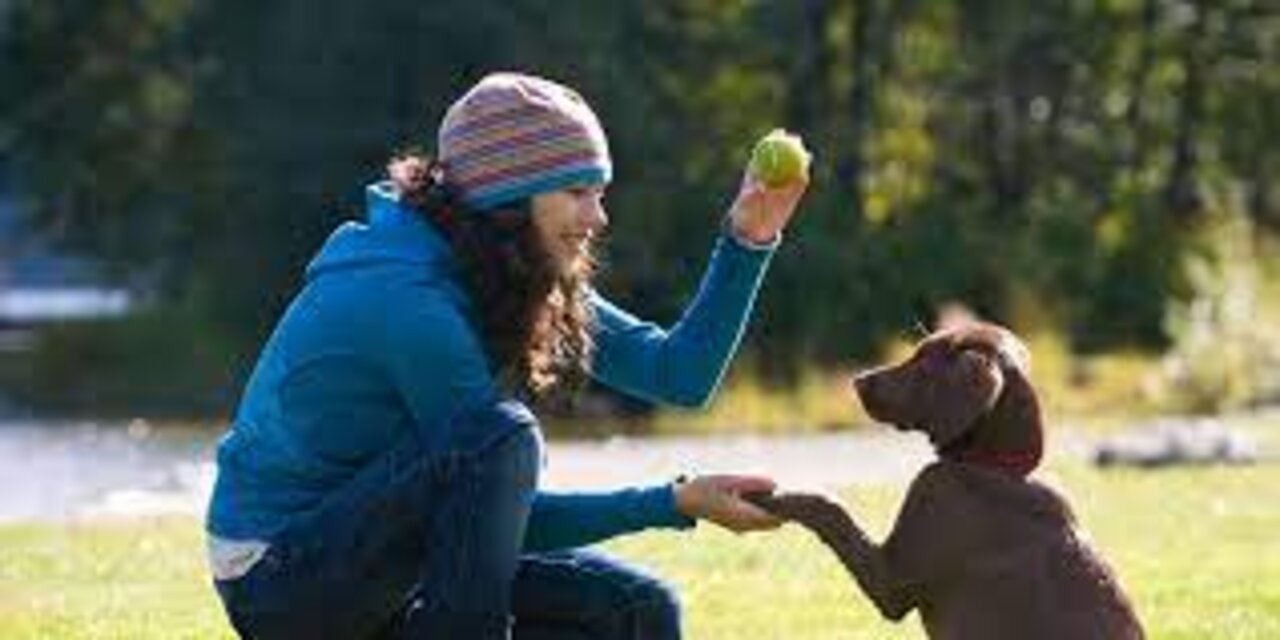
[854,321,1043,475]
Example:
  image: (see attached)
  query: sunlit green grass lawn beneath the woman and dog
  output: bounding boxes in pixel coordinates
[0,463,1280,640]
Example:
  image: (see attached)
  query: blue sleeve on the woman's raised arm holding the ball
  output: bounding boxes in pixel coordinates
[591,233,777,407]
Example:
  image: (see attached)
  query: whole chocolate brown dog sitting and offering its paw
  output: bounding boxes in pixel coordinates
[749,323,1144,640]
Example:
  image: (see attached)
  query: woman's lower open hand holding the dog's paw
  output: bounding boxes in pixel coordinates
[676,475,782,534]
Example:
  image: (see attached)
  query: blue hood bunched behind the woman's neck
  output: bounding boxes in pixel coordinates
[306,182,453,282]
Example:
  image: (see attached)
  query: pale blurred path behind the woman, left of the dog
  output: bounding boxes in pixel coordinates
[0,422,928,522]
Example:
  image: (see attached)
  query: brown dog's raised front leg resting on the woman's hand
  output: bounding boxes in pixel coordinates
[744,493,918,621]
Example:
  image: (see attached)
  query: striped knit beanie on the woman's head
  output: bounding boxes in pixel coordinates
[436,73,613,210]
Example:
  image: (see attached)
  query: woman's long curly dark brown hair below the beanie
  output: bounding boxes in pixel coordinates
[388,152,595,396]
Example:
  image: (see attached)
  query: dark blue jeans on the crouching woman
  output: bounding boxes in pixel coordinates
[215,401,680,640]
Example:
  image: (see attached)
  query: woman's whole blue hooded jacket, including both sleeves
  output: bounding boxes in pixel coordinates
[206,183,774,550]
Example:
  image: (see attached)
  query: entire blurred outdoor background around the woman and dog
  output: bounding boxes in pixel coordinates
[0,0,1280,640]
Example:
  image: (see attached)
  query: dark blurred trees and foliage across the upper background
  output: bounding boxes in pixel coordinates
[0,0,1280,414]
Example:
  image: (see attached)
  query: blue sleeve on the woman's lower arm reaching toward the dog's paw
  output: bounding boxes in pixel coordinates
[524,484,695,552]
